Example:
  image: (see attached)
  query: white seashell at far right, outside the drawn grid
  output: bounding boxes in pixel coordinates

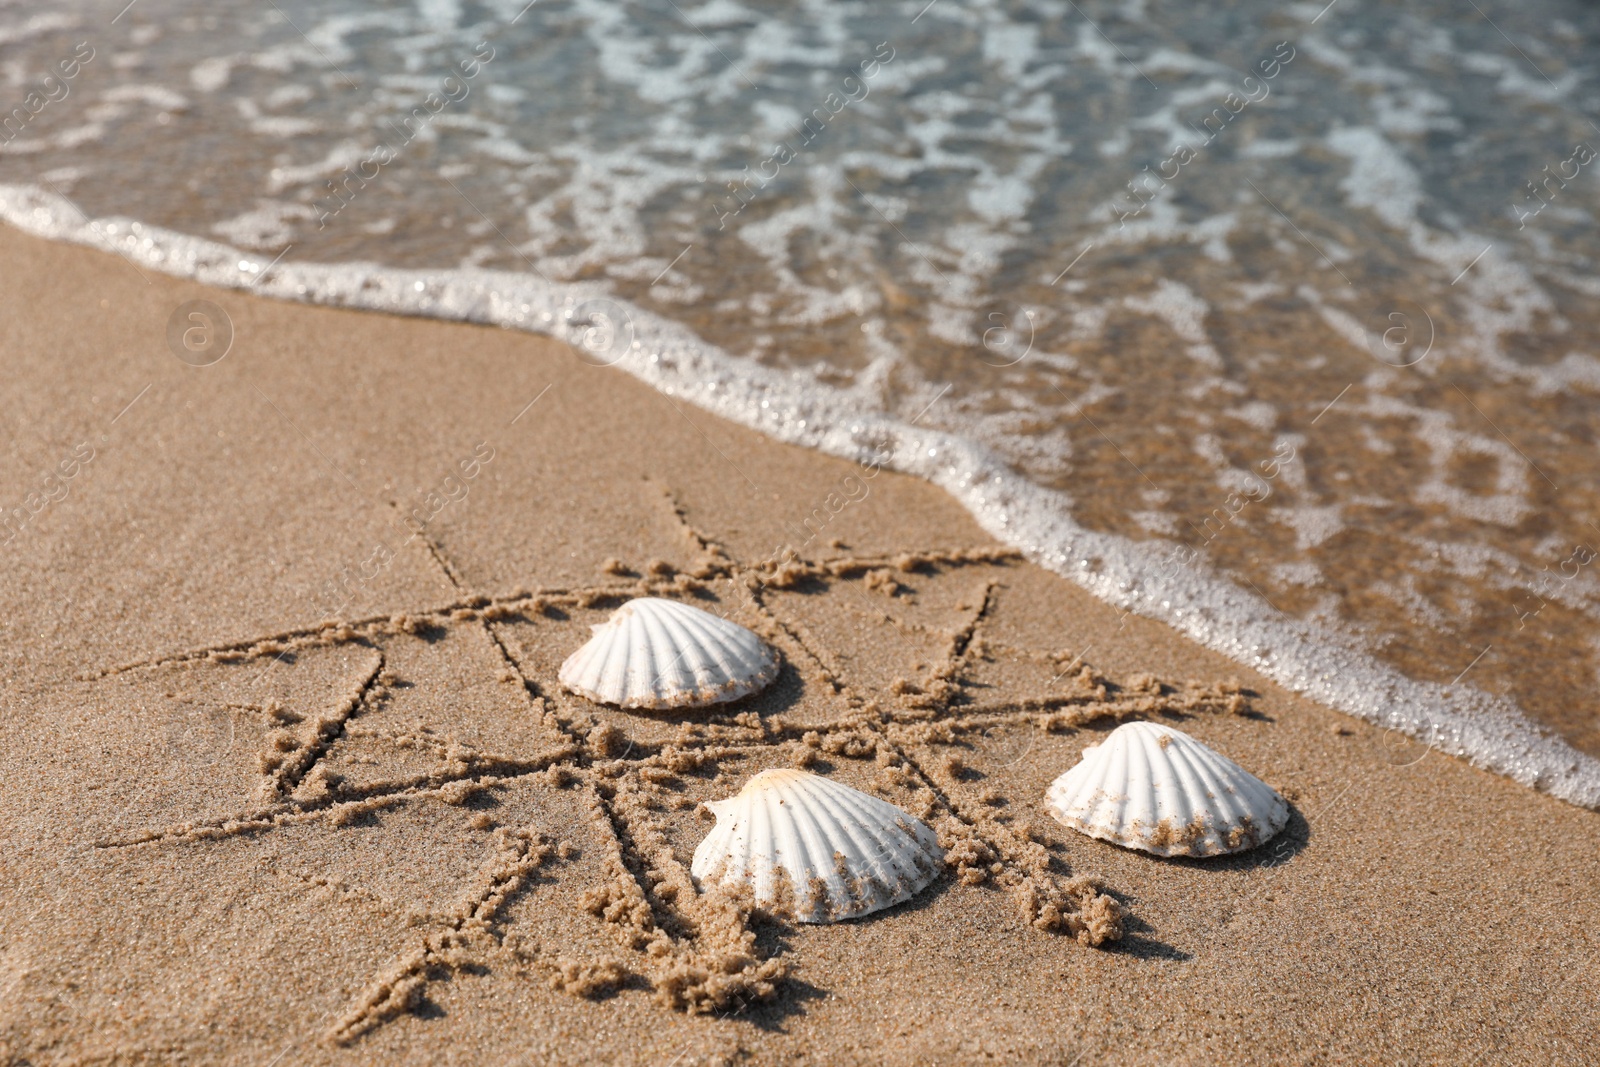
[1045,723,1290,856]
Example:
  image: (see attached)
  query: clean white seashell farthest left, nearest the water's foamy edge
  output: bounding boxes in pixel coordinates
[560,597,778,707]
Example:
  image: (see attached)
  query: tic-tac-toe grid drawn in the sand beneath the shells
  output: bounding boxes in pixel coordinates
[94,504,1246,1043]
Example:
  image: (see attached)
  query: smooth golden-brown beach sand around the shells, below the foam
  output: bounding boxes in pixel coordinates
[0,220,1600,1065]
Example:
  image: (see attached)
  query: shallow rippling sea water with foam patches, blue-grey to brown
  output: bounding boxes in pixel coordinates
[0,0,1600,793]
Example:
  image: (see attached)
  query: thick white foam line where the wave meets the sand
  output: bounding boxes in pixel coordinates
[0,186,1600,808]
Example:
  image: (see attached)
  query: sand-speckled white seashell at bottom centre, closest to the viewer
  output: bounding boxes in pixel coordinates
[690,769,944,923]
